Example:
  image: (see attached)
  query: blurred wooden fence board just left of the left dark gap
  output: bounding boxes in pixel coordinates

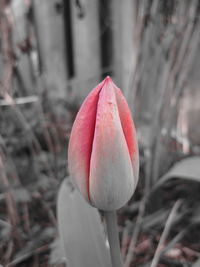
[33,0,67,99]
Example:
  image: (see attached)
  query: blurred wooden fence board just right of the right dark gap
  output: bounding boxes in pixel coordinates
[112,0,136,90]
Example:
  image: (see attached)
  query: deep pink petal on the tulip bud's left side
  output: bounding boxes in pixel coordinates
[68,81,104,201]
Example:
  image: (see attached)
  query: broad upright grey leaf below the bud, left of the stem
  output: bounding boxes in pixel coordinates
[57,180,111,267]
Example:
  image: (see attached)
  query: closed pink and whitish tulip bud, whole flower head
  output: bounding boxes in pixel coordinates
[68,77,139,211]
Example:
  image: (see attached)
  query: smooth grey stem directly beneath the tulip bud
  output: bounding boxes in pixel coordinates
[104,211,123,267]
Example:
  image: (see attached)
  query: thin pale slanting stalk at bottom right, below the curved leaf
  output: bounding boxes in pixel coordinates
[150,199,181,267]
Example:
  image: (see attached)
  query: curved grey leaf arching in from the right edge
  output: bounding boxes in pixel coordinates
[153,157,200,190]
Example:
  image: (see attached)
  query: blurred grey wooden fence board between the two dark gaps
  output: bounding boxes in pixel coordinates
[71,0,101,101]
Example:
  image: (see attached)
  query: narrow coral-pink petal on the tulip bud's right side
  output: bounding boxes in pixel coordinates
[115,87,139,186]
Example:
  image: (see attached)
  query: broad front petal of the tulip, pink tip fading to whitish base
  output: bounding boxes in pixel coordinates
[89,77,134,210]
